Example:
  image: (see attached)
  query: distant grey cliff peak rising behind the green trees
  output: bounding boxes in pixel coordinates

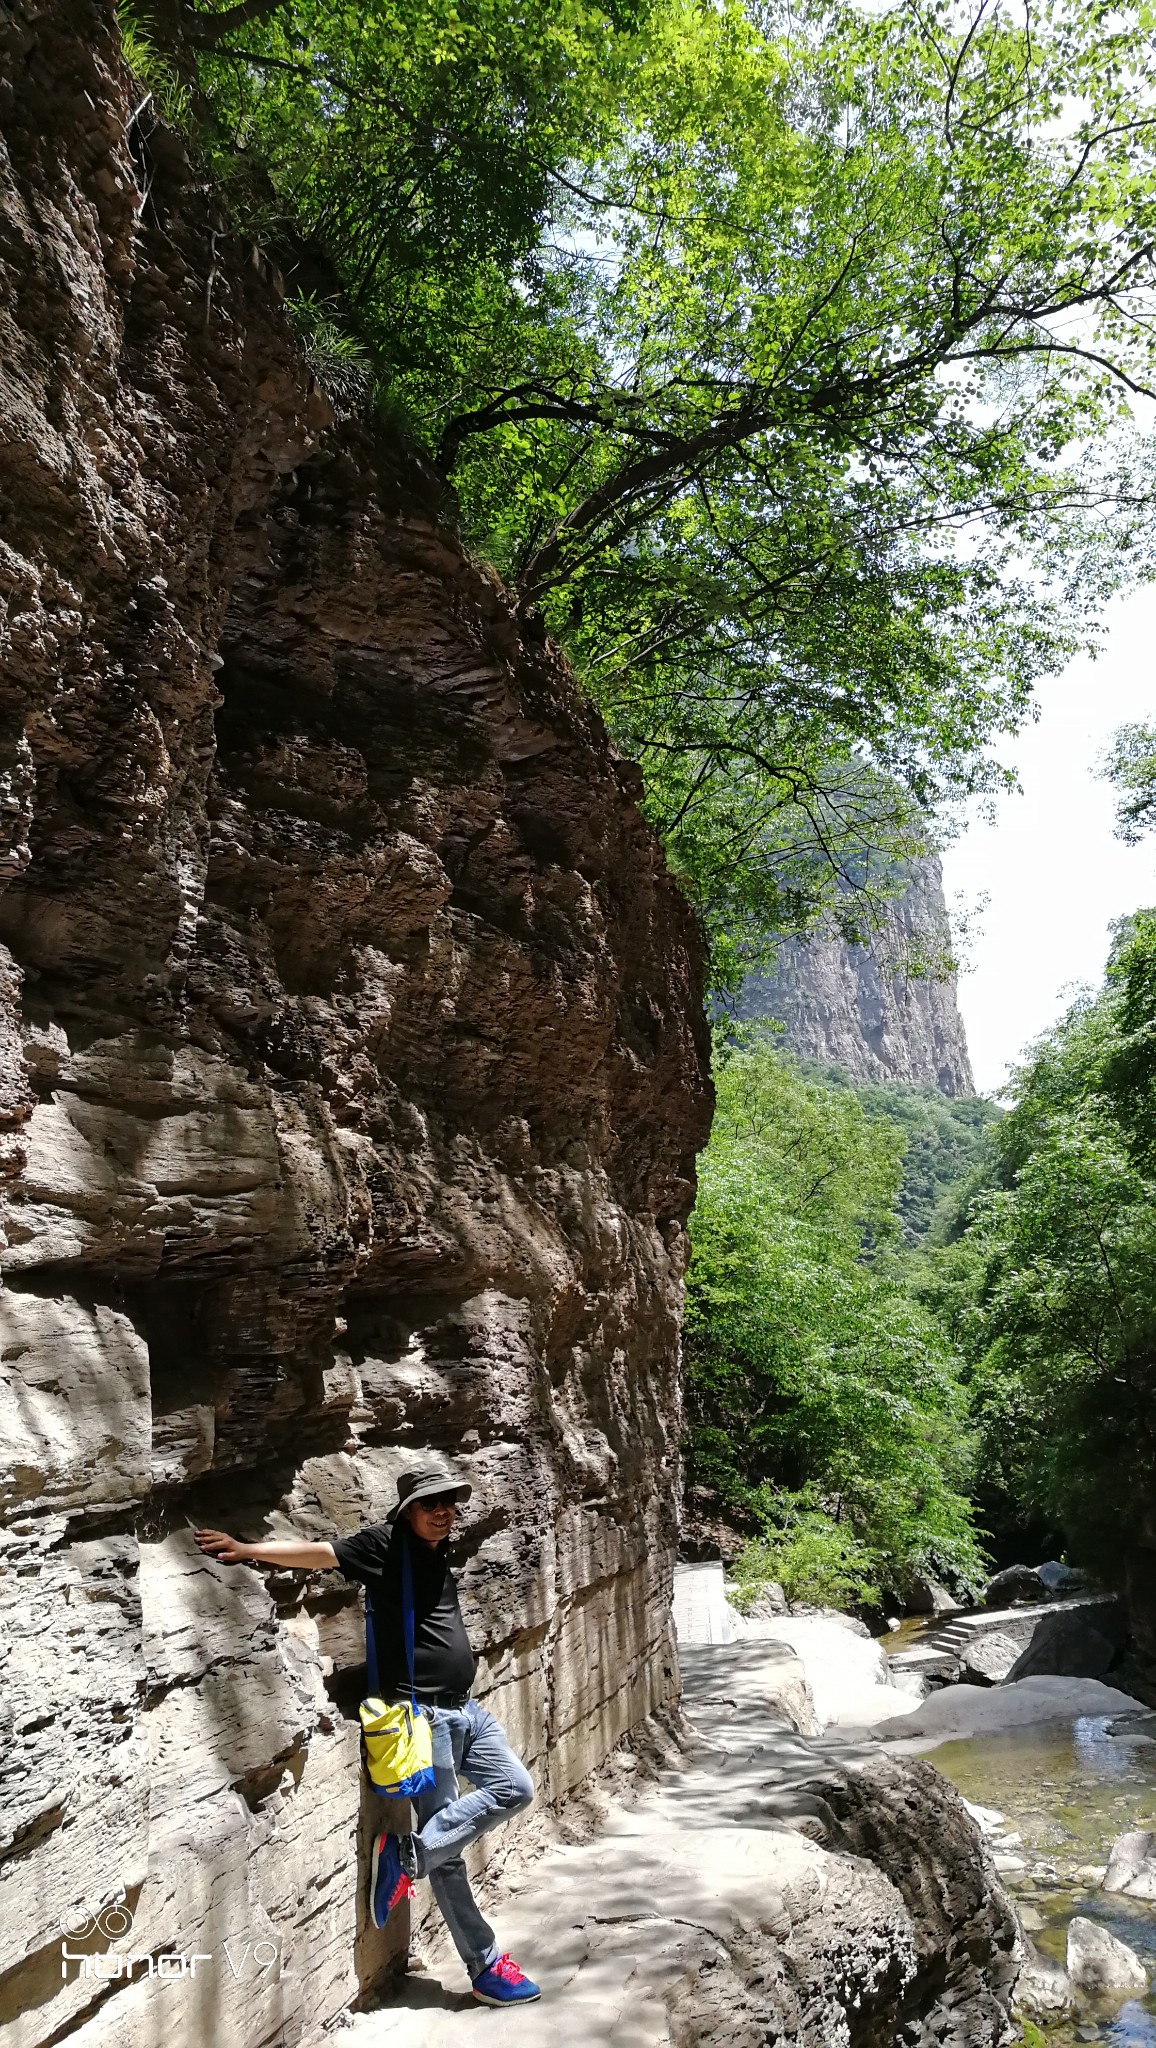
[738,858,976,1096]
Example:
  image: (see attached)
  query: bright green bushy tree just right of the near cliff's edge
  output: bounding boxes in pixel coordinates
[685,1044,982,1593]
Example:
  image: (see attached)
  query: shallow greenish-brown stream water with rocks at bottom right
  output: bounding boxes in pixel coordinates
[926,1712,1156,2048]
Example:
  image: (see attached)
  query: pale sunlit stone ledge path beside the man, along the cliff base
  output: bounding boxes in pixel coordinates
[305,1567,998,2048]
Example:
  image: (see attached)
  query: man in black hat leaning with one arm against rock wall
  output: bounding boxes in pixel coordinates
[195,1464,541,2005]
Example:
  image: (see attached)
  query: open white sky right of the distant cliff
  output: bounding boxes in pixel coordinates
[943,588,1156,1094]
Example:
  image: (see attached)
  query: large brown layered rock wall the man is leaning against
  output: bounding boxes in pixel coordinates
[0,0,709,2048]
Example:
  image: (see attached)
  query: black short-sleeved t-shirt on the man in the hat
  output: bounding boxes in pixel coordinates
[334,1522,478,1700]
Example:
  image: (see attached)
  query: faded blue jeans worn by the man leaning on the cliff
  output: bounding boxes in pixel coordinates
[410,1700,533,1980]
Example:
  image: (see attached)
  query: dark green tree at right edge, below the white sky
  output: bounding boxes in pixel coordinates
[941,913,1156,1577]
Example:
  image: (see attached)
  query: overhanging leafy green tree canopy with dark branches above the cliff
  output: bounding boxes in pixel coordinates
[155,0,1156,983]
